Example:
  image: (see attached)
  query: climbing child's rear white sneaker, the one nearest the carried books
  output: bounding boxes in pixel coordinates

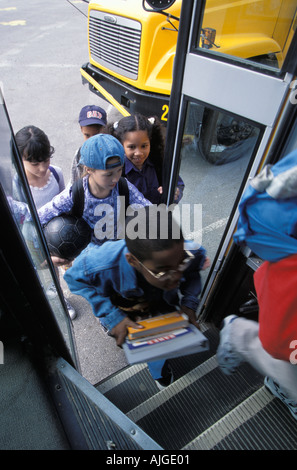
[217,315,242,375]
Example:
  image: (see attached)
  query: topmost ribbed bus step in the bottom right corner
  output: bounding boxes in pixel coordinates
[183,387,297,450]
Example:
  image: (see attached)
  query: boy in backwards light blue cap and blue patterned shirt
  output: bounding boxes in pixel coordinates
[38,134,151,258]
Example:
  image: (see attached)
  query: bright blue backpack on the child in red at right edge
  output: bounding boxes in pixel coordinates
[234,150,297,262]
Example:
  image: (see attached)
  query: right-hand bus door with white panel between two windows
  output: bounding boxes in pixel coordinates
[164,0,297,321]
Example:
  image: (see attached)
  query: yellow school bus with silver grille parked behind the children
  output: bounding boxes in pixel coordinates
[81,0,295,125]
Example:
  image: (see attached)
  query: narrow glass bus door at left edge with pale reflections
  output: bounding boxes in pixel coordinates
[0,88,78,367]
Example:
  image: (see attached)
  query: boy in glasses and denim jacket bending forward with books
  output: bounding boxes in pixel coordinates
[64,205,209,388]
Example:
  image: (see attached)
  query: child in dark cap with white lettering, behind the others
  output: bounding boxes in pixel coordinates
[70,105,107,184]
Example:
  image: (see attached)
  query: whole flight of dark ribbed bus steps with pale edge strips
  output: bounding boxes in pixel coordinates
[97,328,297,450]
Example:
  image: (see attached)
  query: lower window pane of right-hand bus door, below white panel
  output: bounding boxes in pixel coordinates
[179,101,261,272]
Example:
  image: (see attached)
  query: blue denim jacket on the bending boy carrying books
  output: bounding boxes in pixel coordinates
[64,240,206,330]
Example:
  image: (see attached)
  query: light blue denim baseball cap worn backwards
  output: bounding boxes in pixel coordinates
[79,134,125,170]
